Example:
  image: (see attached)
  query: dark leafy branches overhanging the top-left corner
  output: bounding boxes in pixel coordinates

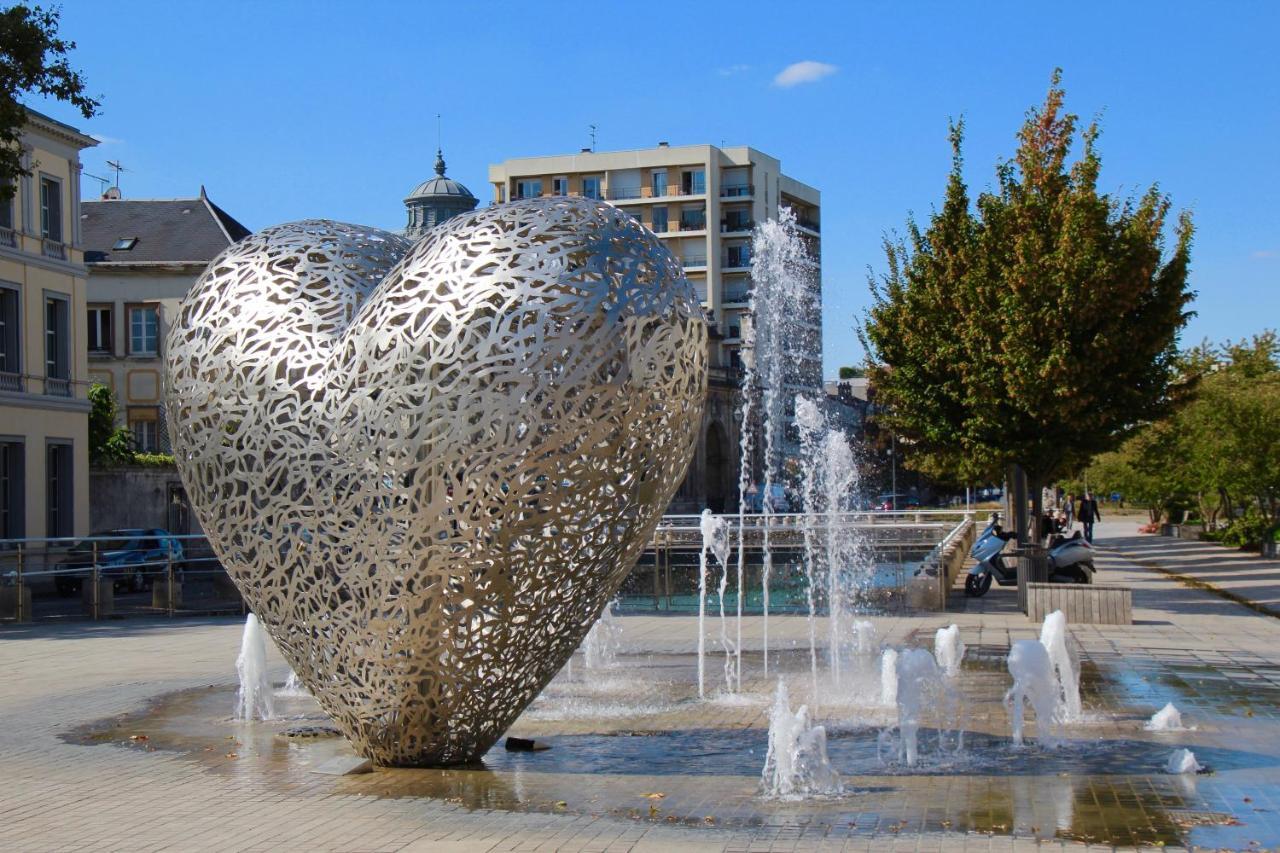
[0,3,100,199]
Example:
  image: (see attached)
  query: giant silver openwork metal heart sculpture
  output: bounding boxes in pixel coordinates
[165,199,707,766]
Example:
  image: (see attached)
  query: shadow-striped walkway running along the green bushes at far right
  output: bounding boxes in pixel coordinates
[1098,520,1280,617]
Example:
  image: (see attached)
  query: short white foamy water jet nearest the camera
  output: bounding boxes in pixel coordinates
[760,679,841,798]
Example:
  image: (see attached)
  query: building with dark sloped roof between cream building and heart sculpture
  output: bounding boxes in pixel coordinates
[79,187,250,453]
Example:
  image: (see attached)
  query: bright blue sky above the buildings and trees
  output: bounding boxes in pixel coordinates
[32,0,1280,373]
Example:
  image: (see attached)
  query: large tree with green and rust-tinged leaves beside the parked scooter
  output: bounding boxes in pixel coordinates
[859,72,1193,530]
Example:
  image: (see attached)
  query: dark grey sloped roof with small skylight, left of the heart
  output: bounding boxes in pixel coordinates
[81,187,250,265]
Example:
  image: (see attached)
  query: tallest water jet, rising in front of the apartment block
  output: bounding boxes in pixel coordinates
[737,206,819,688]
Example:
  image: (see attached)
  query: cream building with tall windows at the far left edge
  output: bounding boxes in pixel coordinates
[0,110,97,539]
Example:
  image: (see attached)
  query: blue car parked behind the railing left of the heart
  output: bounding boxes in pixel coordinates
[54,528,183,596]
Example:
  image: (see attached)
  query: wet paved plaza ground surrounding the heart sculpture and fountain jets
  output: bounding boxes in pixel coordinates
[0,521,1280,852]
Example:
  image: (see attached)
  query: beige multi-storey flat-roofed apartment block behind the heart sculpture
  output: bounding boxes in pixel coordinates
[489,142,822,511]
